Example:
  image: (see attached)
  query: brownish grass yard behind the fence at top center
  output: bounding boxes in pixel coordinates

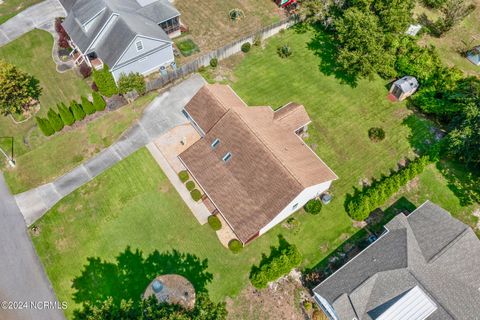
[175,0,283,59]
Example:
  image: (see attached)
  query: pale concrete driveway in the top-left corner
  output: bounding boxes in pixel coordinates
[0,0,66,47]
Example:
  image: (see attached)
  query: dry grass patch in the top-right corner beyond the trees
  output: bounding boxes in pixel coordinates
[415,0,480,76]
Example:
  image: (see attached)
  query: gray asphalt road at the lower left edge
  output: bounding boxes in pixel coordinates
[0,173,65,320]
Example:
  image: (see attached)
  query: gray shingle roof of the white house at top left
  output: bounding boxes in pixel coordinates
[62,0,180,67]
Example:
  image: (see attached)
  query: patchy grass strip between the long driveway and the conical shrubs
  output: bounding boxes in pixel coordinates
[4,92,157,194]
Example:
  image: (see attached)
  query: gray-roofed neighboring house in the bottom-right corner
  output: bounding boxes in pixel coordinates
[313,201,480,320]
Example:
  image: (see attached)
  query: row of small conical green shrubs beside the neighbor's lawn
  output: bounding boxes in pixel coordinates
[35,92,107,137]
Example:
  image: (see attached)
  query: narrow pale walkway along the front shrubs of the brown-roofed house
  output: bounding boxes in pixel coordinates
[147,142,210,225]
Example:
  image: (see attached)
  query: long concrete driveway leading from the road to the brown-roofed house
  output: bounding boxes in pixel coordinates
[15,75,205,225]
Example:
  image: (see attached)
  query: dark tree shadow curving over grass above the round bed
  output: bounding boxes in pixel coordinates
[72,247,213,305]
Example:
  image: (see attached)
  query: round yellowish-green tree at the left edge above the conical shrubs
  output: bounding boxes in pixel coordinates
[0,60,42,115]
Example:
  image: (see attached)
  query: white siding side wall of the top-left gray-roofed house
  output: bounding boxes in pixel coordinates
[111,43,174,81]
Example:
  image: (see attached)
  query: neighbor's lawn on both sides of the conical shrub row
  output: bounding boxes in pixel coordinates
[0,30,155,193]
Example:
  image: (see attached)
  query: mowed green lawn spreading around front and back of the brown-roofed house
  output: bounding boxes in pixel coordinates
[32,26,478,316]
